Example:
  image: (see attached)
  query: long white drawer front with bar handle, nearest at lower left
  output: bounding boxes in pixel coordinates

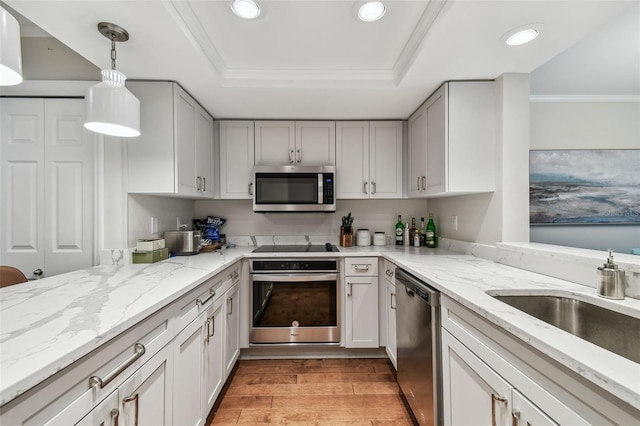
[0,307,174,425]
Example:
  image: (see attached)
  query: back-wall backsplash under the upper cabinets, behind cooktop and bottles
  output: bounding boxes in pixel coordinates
[195,200,428,241]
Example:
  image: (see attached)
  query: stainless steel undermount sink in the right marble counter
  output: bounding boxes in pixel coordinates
[493,295,640,363]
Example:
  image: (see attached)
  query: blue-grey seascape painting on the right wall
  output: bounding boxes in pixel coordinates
[529,149,640,225]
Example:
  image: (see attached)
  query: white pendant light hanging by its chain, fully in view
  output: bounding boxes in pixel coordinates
[84,22,140,138]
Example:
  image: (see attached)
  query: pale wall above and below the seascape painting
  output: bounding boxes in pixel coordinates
[530,98,640,253]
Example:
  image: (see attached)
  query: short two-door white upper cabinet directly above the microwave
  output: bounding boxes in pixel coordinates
[255,121,336,165]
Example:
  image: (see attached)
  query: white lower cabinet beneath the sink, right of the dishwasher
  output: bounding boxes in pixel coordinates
[441,295,638,426]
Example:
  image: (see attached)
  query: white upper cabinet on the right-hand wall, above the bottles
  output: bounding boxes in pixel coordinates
[409,81,496,197]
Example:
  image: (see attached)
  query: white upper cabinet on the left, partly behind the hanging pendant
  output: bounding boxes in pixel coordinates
[127,81,214,198]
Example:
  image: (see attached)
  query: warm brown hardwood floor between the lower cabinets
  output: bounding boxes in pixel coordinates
[207,359,413,426]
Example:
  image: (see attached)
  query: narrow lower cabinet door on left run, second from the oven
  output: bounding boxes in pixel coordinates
[203,297,225,412]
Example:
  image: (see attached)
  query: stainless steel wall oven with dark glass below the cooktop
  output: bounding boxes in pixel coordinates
[249,258,340,344]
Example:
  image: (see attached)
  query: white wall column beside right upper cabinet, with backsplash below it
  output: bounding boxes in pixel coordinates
[429,74,529,244]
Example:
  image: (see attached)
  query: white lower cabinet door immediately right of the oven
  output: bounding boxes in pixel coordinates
[344,276,379,348]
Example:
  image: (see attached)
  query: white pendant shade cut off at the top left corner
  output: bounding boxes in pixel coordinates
[0,7,22,86]
